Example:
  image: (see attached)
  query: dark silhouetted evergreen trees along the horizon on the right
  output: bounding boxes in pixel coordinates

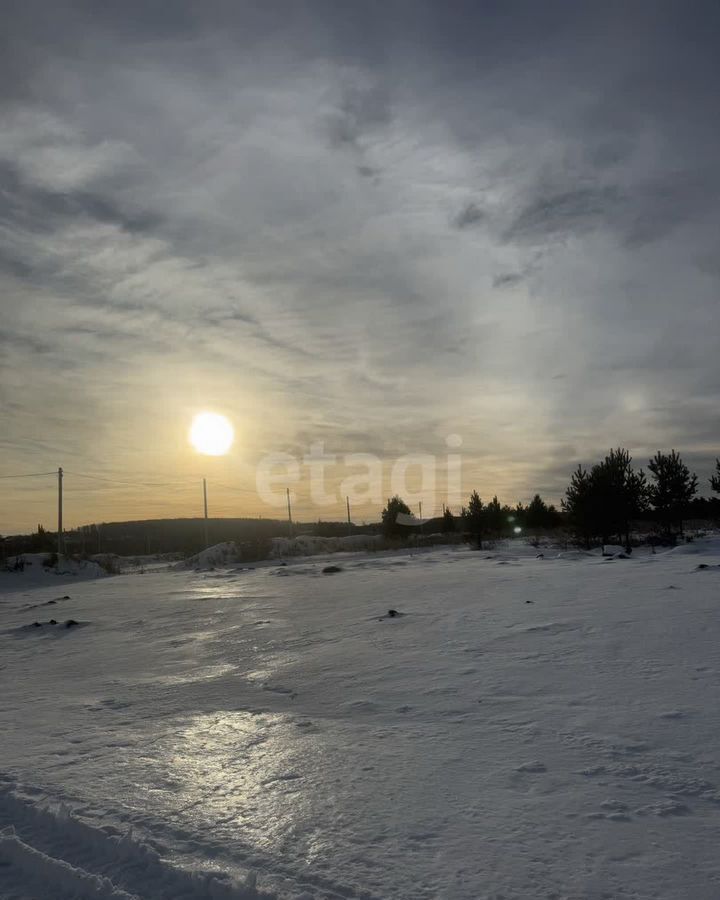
[382,447,720,548]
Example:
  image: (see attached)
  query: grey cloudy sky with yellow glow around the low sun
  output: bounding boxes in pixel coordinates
[0,0,720,533]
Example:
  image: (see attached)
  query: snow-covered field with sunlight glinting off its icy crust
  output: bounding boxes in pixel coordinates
[0,540,720,900]
